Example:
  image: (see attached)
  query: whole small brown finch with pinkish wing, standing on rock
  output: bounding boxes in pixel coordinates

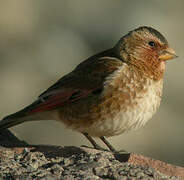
[0,26,177,152]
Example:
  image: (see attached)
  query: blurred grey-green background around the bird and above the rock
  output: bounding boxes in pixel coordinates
[0,0,184,166]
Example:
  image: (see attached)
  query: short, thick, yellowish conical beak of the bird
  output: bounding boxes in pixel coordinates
[159,47,178,61]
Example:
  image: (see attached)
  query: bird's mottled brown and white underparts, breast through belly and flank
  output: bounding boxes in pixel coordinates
[59,65,163,137]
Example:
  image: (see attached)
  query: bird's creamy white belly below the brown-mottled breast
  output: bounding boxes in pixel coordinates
[82,83,160,137]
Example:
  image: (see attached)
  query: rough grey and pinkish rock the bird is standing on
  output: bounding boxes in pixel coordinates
[0,130,184,180]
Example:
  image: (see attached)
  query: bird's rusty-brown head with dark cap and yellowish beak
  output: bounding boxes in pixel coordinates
[115,26,177,80]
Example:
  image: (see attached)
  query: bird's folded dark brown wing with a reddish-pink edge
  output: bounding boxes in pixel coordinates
[26,54,123,114]
